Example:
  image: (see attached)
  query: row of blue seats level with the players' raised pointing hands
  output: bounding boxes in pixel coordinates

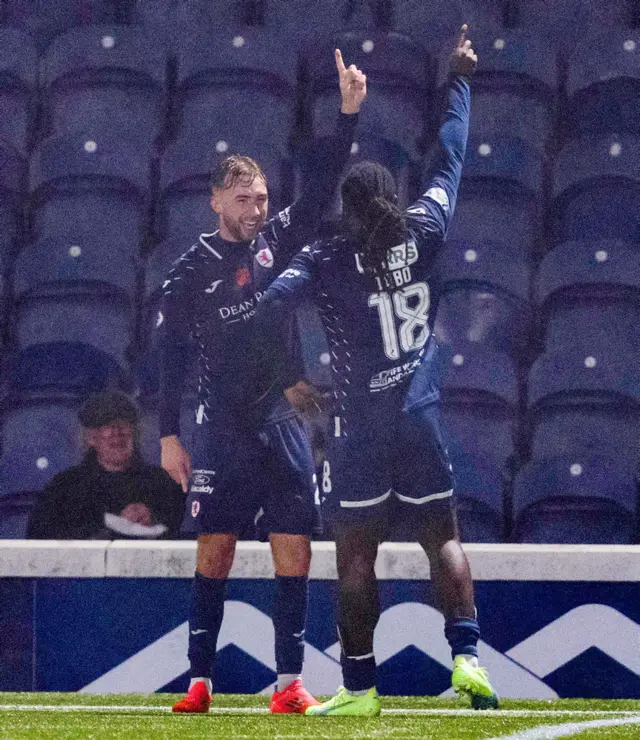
[0,19,640,159]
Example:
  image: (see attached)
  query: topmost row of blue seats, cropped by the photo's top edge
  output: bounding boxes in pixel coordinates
[0,0,640,51]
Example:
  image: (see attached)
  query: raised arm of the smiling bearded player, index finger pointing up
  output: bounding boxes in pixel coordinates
[269,49,367,261]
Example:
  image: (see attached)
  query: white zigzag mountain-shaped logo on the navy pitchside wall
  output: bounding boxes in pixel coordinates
[82,601,640,699]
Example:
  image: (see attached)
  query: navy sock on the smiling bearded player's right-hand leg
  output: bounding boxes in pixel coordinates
[273,575,308,675]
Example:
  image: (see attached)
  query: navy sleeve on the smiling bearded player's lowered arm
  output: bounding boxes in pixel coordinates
[159,262,194,438]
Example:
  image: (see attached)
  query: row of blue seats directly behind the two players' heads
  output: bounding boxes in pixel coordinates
[0,123,640,278]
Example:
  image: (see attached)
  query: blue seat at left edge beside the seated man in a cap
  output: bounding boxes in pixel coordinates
[0,396,82,494]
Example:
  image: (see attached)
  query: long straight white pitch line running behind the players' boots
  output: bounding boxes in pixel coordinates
[0,704,640,722]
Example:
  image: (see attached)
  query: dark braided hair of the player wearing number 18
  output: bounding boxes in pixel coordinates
[341,161,407,275]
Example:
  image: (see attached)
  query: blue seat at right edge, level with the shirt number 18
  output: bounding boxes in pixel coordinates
[536,240,640,352]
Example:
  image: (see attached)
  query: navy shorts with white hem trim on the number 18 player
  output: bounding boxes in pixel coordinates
[318,401,453,524]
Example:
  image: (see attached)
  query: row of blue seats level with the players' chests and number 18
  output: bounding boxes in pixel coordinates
[6,234,640,370]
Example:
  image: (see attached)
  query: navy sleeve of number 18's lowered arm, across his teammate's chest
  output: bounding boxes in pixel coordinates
[253,246,318,388]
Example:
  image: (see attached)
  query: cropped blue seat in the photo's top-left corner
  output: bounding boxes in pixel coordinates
[3,0,119,52]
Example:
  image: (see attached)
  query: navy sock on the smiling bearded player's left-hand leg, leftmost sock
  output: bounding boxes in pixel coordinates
[187,571,226,678]
